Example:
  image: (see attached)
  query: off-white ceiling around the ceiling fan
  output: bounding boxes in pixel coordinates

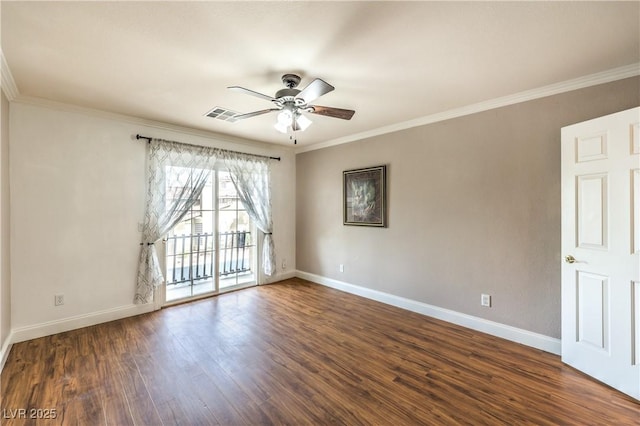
[0,1,640,146]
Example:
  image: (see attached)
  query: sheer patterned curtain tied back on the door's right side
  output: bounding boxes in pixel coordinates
[221,151,276,276]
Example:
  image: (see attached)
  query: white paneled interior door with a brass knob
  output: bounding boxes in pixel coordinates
[562,108,640,399]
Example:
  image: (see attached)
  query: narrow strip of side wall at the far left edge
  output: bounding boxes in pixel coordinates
[0,90,11,350]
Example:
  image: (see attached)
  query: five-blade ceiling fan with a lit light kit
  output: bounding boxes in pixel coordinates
[220,74,355,140]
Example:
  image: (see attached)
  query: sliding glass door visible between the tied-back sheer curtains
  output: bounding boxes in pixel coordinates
[165,166,257,303]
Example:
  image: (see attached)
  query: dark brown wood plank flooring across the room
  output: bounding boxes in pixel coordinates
[0,279,640,426]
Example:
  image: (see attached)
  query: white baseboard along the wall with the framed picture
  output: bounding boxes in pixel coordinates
[296,271,562,355]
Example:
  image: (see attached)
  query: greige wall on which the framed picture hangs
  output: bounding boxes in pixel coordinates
[296,77,640,338]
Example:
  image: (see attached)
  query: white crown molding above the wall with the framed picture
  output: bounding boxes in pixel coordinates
[295,62,640,154]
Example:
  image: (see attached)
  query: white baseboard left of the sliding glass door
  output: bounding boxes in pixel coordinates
[11,303,154,343]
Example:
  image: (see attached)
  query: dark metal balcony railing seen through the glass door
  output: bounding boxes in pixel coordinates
[166,231,252,285]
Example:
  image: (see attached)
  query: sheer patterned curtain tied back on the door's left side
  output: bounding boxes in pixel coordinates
[134,139,219,303]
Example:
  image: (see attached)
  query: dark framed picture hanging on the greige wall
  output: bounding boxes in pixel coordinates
[342,165,387,228]
